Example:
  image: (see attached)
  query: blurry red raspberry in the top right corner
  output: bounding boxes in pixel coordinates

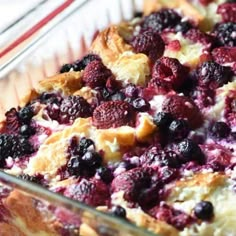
[217,3,236,22]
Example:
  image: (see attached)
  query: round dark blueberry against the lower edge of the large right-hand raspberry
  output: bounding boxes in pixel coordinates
[169,119,190,141]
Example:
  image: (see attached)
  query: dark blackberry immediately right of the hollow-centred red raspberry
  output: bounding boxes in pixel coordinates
[196,61,231,89]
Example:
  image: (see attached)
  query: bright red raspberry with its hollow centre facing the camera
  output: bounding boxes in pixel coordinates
[152,57,187,89]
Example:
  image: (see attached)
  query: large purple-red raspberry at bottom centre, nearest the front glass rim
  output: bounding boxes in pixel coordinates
[111,167,156,202]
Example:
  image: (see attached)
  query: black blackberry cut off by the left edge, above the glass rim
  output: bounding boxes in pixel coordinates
[0,134,34,165]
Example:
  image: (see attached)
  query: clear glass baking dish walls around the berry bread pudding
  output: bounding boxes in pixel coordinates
[0,0,157,236]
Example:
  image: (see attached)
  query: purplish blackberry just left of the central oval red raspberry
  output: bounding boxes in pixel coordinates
[59,96,92,124]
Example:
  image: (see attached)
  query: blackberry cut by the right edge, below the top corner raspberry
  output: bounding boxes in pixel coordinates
[214,22,236,47]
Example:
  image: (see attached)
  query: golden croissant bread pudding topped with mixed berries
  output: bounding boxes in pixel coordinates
[0,0,236,236]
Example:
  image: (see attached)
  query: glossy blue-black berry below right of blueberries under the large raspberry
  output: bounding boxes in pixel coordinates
[178,139,205,163]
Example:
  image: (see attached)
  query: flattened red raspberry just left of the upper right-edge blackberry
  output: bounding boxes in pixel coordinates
[185,29,214,48]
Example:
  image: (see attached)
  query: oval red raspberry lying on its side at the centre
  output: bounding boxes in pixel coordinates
[93,101,135,129]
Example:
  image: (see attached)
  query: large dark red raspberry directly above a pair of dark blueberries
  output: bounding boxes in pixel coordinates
[162,95,202,128]
